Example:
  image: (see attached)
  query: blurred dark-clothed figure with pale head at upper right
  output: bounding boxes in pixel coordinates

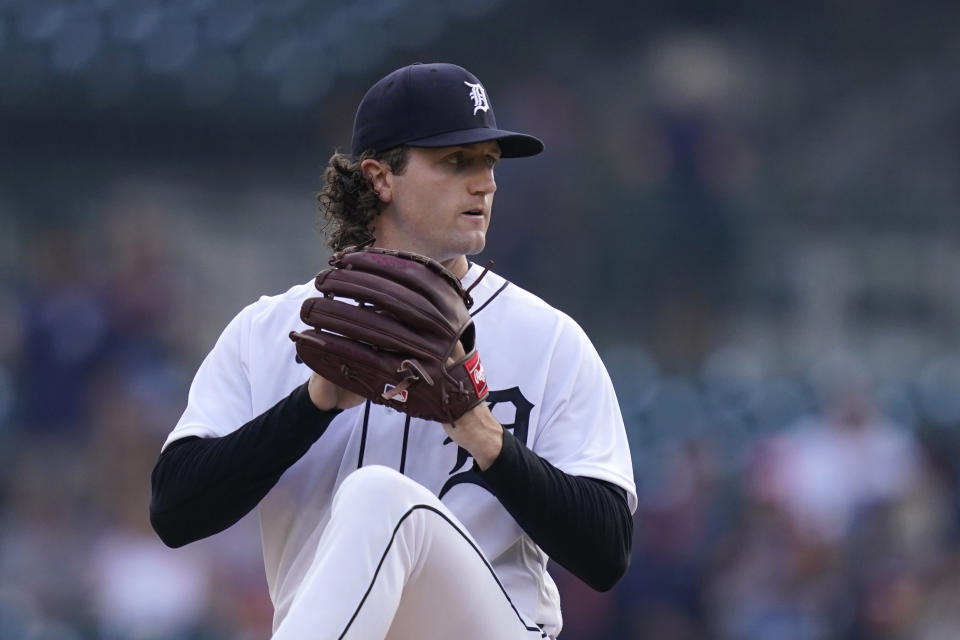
[592,35,754,371]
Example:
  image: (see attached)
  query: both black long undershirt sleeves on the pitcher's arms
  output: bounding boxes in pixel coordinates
[150,384,633,591]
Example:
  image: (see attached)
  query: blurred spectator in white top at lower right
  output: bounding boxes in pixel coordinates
[711,360,924,640]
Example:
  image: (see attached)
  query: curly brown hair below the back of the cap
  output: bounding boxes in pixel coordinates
[317,146,409,251]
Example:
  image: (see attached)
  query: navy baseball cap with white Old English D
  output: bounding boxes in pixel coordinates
[350,63,543,158]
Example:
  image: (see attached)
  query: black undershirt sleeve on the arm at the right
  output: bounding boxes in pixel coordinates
[480,429,633,591]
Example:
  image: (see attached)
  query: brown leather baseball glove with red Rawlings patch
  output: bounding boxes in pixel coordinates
[290,247,487,423]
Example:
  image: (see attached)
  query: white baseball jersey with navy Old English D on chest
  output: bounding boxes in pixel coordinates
[164,264,637,635]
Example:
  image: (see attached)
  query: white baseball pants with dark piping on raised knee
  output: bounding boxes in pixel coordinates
[273,466,543,640]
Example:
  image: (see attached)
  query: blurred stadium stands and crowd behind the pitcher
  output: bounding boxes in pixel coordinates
[0,0,960,640]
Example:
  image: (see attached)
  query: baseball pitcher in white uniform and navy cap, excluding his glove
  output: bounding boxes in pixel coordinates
[150,64,637,640]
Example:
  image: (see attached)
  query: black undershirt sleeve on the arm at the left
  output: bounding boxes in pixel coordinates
[150,383,340,547]
